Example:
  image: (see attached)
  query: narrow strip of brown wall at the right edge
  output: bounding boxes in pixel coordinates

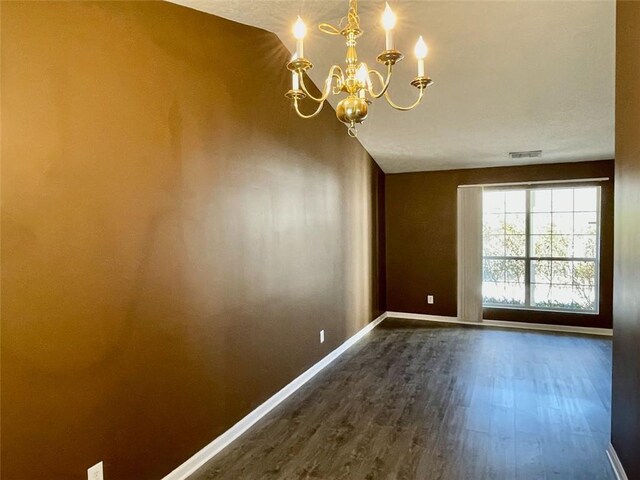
[611,1,640,479]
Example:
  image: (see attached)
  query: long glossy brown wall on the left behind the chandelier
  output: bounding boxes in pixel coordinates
[1,2,384,480]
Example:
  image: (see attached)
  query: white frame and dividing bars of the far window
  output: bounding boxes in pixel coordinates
[482,182,602,315]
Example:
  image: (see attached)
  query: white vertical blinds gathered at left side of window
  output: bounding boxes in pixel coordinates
[458,187,482,322]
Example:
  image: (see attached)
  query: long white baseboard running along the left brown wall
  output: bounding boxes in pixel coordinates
[162,312,387,480]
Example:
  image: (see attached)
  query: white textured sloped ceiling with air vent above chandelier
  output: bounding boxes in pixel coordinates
[174,0,615,173]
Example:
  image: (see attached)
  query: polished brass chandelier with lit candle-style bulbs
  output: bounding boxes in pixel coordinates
[285,0,433,137]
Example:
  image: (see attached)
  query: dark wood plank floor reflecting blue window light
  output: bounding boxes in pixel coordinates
[192,320,614,480]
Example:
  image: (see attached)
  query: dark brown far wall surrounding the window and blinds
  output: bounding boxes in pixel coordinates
[385,161,614,328]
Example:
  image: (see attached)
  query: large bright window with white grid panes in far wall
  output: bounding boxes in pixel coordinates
[482,187,600,313]
